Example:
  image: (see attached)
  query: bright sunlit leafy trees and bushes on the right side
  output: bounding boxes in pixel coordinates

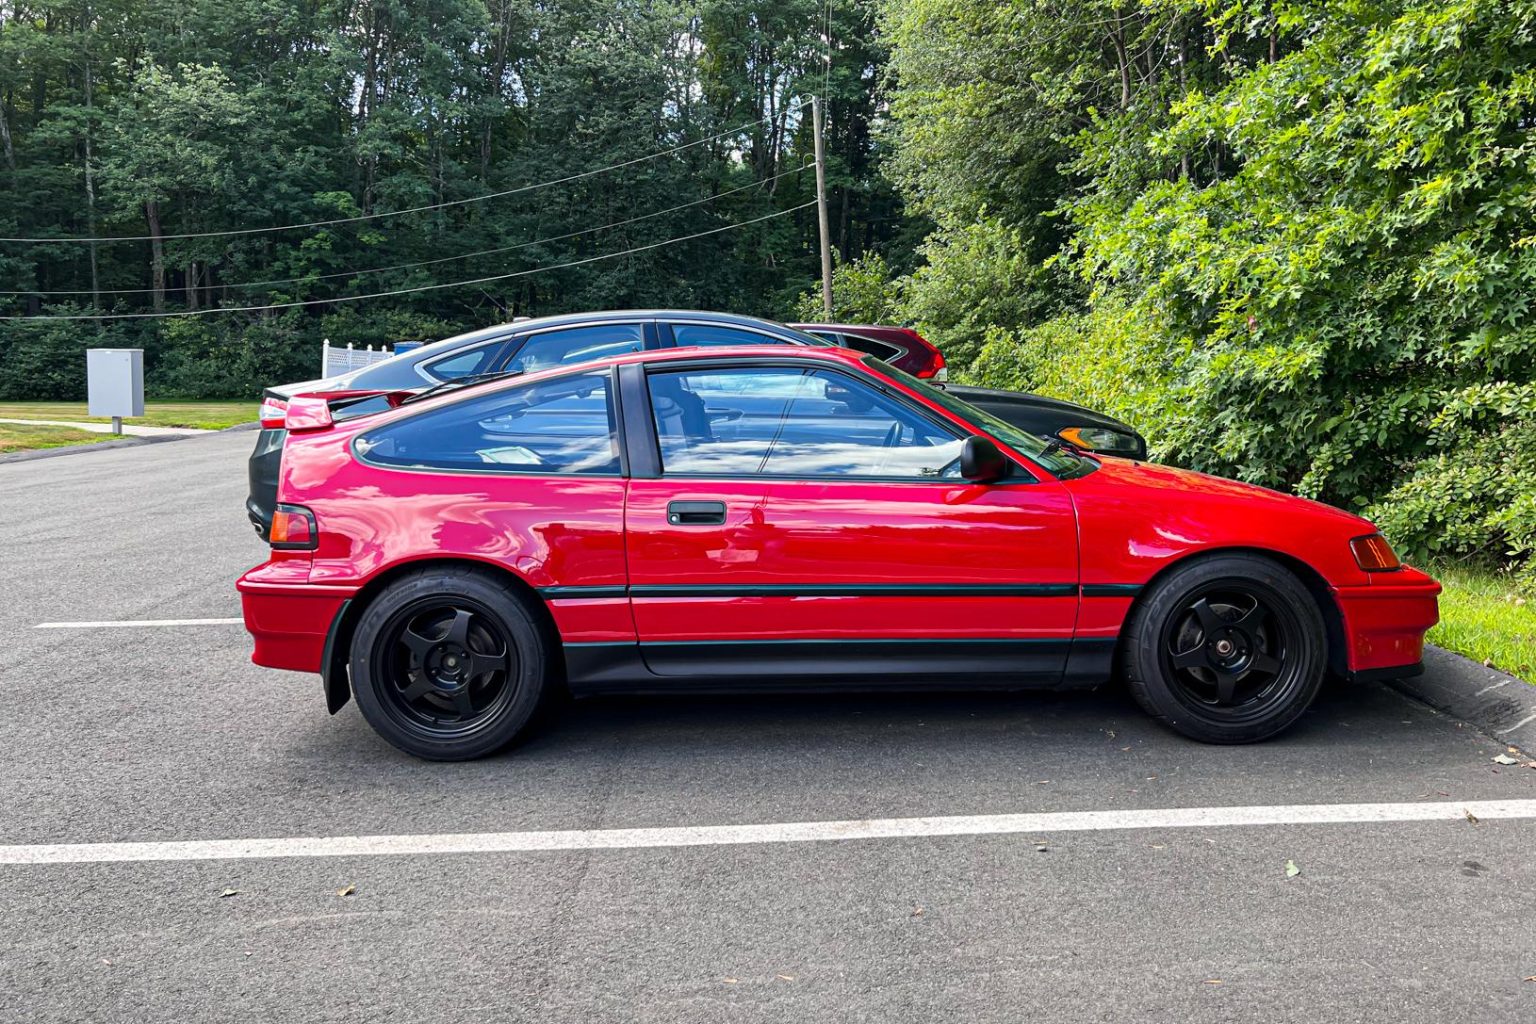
[882,0,1536,589]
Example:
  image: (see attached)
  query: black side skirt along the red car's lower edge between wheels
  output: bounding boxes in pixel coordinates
[565,639,1115,695]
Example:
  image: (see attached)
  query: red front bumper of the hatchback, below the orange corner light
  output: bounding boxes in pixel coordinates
[1333,567,1441,680]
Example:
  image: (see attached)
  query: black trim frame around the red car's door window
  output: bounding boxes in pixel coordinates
[621,356,1041,487]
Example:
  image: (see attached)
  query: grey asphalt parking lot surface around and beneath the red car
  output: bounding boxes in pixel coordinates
[0,433,1536,1022]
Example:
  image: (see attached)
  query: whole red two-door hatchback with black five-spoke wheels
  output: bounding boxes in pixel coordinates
[238,347,1439,758]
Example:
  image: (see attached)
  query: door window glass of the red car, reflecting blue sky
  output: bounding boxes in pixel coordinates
[648,367,963,479]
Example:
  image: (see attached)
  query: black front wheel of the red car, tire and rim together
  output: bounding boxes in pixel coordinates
[1121,554,1329,743]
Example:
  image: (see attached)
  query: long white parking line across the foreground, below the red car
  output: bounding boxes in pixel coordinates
[0,800,1536,864]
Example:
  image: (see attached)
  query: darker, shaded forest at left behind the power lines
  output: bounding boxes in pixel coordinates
[0,0,911,398]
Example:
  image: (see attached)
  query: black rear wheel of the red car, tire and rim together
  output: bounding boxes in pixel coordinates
[350,570,551,761]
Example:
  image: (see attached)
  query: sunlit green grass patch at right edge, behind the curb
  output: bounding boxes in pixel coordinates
[1428,567,1536,683]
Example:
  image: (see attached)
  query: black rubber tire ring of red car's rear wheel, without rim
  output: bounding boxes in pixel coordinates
[349,571,550,761]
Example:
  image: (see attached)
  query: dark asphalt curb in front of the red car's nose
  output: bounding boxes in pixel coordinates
[1387,645,1536,752]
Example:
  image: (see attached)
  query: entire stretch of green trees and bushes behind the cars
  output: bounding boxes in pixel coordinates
[0,0,1536,577]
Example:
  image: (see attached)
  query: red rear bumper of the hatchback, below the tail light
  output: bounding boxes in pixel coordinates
[235,562,356,672]
